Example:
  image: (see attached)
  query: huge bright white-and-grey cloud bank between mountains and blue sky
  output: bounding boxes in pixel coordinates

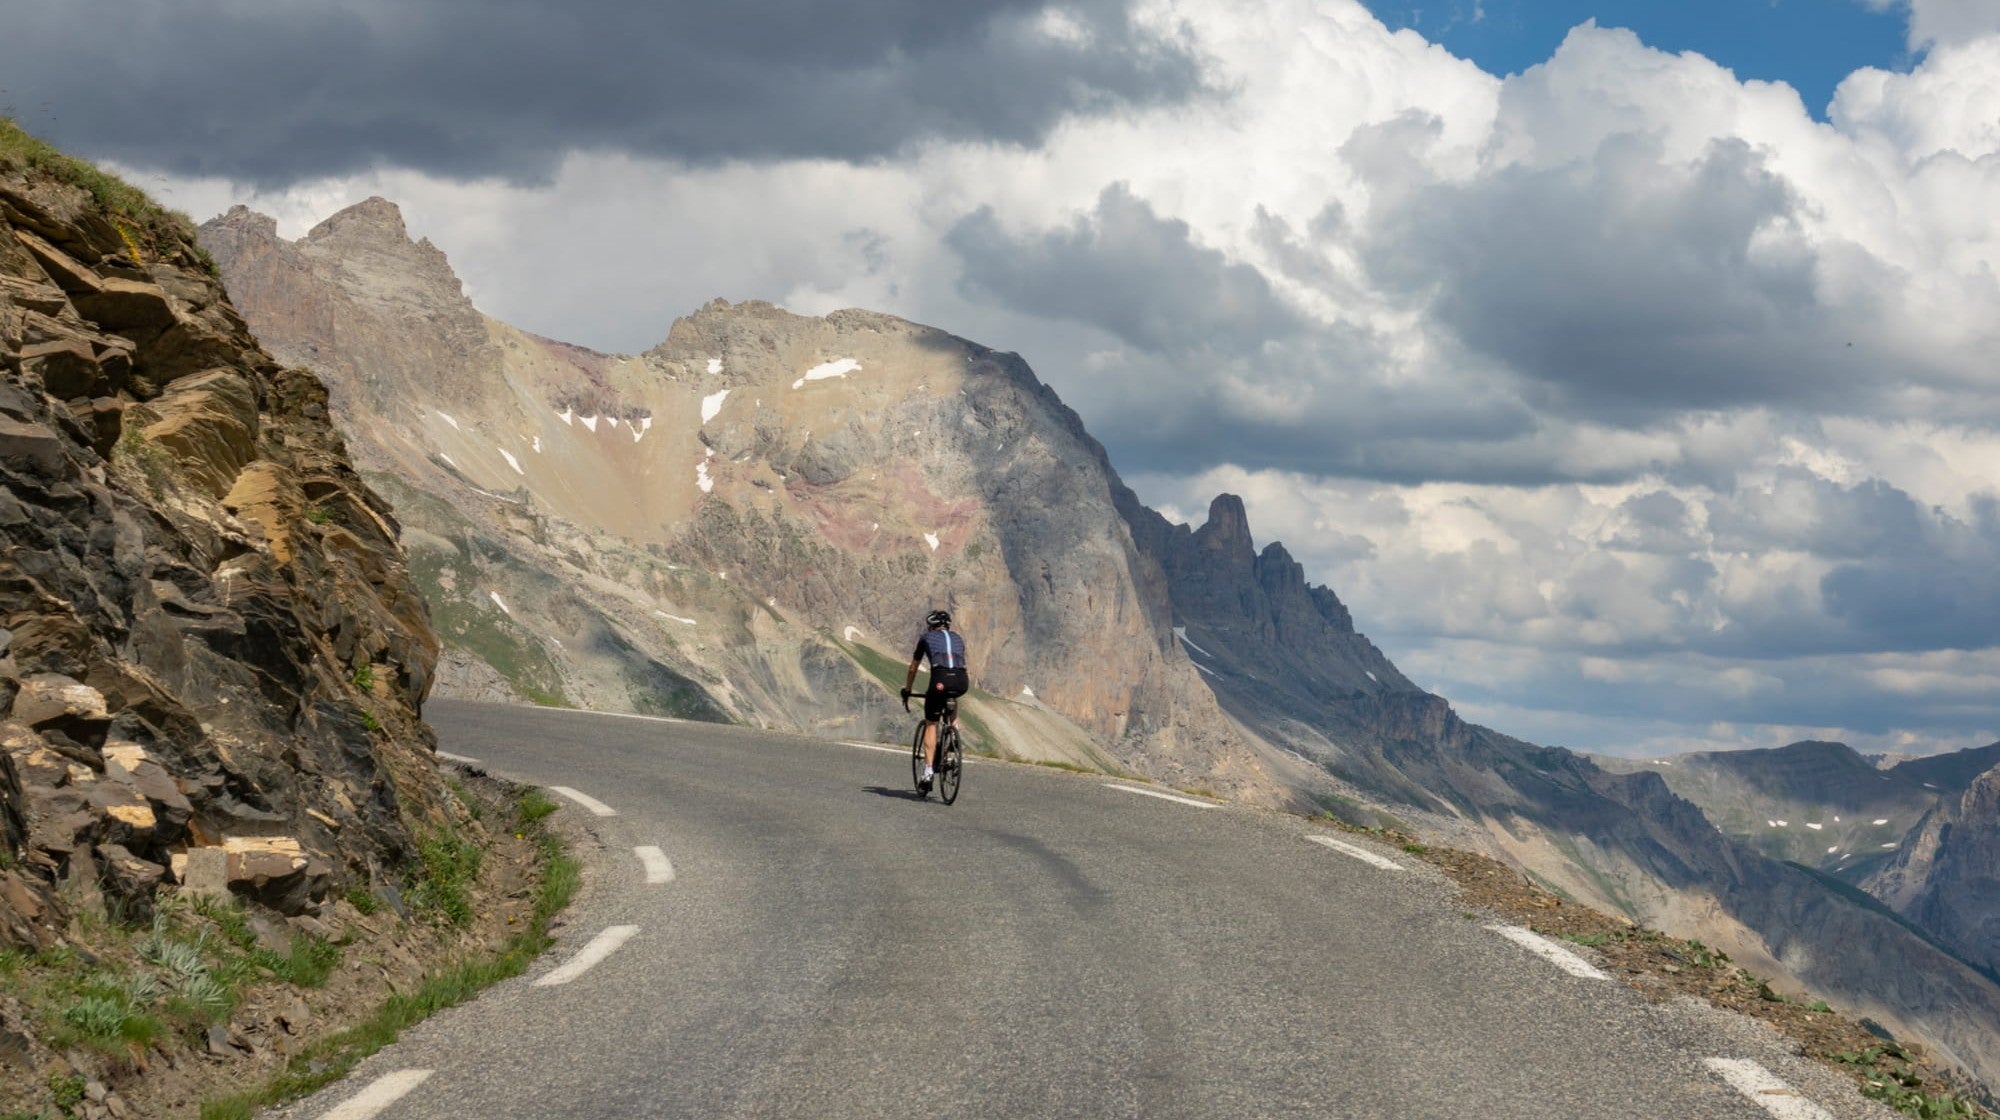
[140,0,2000,746]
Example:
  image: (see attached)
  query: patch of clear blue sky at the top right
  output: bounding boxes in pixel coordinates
[1368,0,1910,118]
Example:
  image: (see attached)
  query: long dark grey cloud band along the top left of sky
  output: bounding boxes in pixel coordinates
[0,0,1198,186]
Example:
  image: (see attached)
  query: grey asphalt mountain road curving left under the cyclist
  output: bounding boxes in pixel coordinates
[270,702,1880,1120]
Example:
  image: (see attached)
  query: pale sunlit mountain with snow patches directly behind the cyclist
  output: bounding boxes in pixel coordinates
[204,200,1296,800]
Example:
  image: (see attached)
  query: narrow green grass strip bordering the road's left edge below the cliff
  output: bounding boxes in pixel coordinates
[202,790,582,1120]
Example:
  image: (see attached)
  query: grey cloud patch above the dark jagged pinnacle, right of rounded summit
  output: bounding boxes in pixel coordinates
[946,186,1546,478]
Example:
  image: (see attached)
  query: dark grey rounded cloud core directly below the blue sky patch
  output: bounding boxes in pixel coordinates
[1356,134,1918,424]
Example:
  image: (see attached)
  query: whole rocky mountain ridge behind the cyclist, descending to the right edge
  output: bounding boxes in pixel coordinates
[204,200,2000,1080]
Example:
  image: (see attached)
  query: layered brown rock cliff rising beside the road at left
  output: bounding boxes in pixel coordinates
[0,155,440,948]
